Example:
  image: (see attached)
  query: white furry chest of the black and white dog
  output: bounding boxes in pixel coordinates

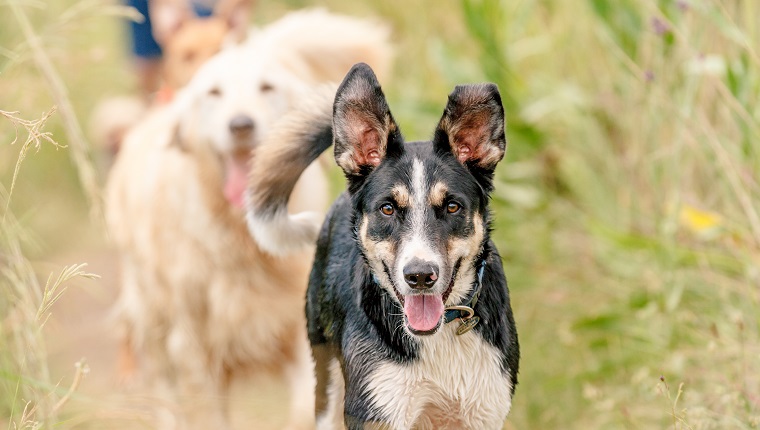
[368,323,512,429]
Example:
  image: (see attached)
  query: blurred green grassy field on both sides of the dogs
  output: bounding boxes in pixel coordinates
[0,0,760,430]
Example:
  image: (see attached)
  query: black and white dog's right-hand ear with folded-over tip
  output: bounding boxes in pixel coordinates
[433,84,507,171]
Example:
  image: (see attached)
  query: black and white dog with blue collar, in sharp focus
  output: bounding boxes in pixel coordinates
[248,64,519,429]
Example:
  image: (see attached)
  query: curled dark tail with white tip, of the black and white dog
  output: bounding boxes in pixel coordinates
[246,85,335,255]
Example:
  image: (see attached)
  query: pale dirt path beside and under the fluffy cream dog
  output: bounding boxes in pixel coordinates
[40,240,287,430]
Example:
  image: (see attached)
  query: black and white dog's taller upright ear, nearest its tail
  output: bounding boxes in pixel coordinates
[333,63,402,178]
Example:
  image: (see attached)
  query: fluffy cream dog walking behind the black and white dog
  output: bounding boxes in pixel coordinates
[107,10,390,429]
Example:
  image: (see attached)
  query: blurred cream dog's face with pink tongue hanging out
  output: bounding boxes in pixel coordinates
[174,44,307,207]
